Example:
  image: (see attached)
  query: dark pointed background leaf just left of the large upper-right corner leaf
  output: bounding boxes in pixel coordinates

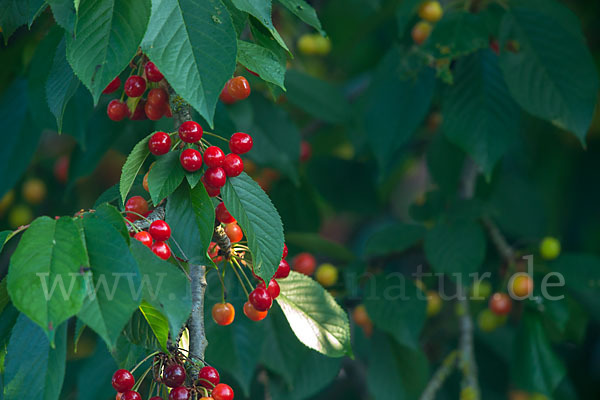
[442,49,520,176]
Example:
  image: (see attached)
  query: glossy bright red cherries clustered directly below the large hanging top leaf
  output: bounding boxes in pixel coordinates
[148,121,253,197]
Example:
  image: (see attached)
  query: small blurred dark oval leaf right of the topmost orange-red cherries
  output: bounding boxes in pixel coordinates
[285,69,350,123]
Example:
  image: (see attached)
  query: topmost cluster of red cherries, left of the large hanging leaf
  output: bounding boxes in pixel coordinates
[102,61,173,121]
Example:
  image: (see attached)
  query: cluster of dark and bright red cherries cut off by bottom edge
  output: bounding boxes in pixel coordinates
[112,363,233,400]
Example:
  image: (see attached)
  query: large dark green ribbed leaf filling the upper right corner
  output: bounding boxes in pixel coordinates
[500,2,599,142]
